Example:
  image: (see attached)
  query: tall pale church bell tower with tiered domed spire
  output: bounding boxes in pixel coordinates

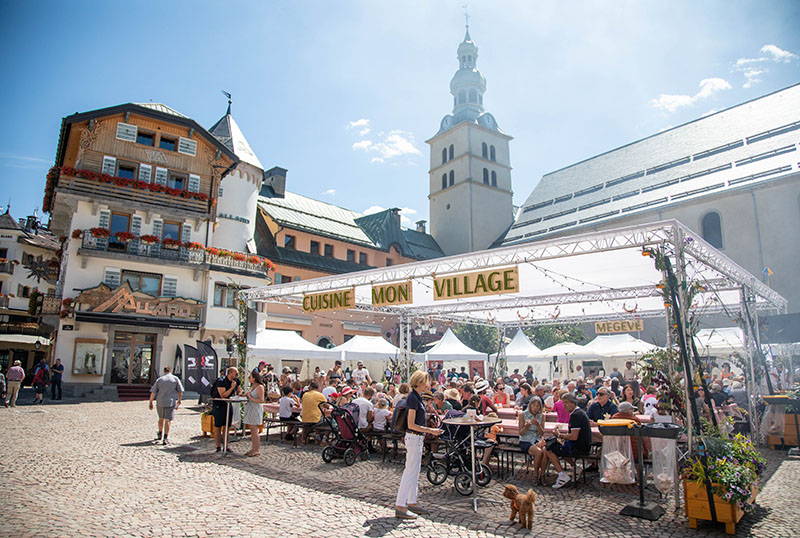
[427,24,514,255]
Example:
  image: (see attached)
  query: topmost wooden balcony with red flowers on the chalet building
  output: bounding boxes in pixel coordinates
[56,173,209,216]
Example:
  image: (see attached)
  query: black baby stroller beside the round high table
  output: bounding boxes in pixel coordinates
[425,410,492,495]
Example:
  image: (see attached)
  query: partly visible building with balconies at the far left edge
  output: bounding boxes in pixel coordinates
[0,209,60,371]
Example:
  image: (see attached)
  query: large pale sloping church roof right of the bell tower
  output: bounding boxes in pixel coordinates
[503,84,800,245]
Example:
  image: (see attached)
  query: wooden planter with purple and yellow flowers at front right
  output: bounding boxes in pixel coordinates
[681,424,766,534]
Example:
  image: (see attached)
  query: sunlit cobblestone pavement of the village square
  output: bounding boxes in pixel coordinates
[0,402,800,538]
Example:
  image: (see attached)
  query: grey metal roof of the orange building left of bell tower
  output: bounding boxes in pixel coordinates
[258,192,444,260]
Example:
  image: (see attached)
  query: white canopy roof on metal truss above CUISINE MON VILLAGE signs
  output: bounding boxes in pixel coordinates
[242,220,787,326]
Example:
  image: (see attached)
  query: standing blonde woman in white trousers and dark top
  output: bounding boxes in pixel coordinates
[394,370,442,519]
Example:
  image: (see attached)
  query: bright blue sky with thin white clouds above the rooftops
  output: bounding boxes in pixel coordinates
[0,0,800,226]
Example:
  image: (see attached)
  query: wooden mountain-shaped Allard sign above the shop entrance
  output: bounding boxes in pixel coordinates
[75,282,203,320]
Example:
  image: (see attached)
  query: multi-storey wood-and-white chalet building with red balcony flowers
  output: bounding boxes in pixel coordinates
[43,103,276,394]
